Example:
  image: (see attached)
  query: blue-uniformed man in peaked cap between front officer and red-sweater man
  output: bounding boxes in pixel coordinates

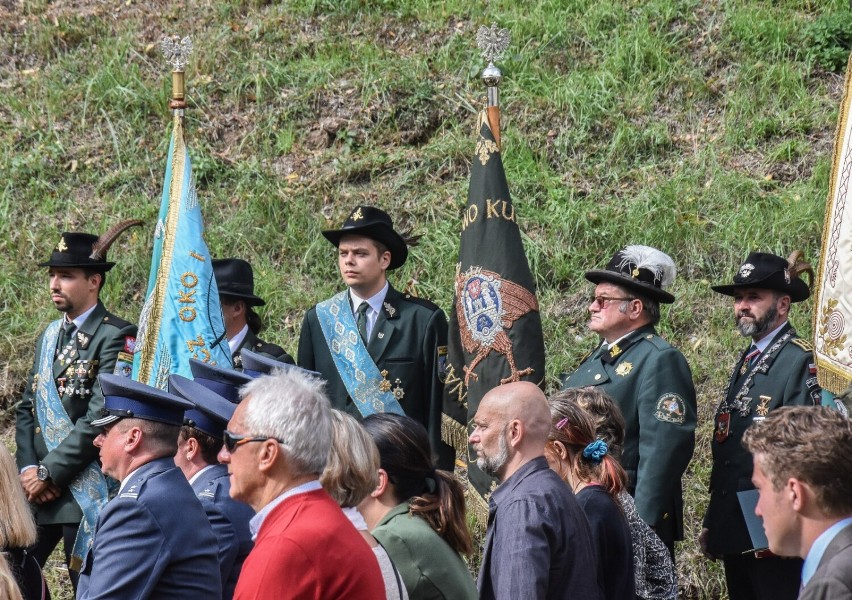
[169,375,254,600]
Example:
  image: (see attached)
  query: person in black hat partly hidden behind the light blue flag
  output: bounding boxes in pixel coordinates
[213,258,294,370]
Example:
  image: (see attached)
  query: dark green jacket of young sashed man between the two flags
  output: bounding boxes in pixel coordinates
[298,286,452,462]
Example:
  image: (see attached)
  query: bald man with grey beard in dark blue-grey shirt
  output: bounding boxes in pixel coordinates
[470,381,602,600]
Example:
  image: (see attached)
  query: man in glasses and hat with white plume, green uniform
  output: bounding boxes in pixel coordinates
[563,246,697,557]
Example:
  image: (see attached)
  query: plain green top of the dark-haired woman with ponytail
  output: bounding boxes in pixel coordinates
[370,502,478,600]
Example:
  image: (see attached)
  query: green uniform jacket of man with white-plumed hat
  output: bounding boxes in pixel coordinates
[563,325,697,544]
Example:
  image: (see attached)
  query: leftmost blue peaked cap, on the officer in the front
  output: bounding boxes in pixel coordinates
[92,373,192,427]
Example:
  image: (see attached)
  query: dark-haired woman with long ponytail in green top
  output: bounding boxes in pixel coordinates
[358,413,477,600]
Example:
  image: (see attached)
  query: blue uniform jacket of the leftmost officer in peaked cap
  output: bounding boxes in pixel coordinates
[77,458,222,600]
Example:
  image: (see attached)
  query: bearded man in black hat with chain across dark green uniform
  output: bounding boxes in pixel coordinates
[699,252,820,600]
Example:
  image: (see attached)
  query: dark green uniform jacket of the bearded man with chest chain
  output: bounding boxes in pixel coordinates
[704,323,821,556]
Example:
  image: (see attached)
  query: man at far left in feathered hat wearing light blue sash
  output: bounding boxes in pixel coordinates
[15,222,138,588]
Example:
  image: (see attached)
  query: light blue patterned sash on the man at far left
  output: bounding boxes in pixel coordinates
[35,319,114,571]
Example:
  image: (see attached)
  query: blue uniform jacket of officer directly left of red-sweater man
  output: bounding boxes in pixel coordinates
[192,465,254,600]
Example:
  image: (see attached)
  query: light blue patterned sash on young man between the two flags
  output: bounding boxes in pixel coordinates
[317,291,405,417]
